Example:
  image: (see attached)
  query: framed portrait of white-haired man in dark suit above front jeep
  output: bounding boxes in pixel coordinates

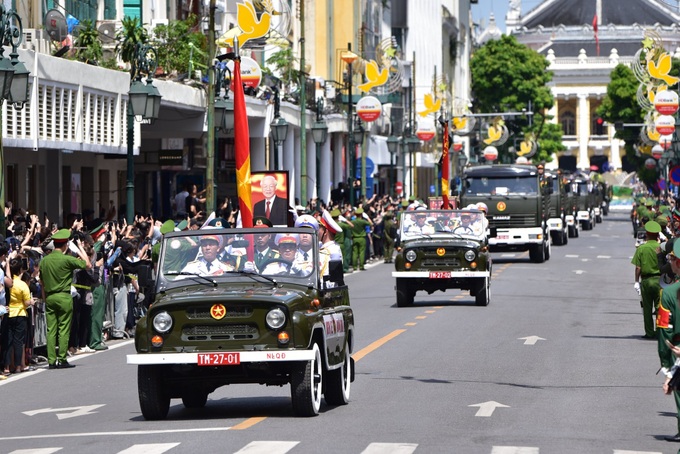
[250,171,289,226]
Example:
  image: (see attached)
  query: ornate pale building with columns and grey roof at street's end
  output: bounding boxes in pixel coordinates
[506,0,680,170]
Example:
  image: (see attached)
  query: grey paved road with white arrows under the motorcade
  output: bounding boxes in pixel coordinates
[0,214,668,454]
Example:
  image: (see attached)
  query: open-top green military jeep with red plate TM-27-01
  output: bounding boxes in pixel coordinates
[127,228,354,420]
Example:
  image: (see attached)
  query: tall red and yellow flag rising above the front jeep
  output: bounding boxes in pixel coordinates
[234,59,253,227]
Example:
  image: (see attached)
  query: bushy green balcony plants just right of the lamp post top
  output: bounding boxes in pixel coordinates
[152,15,210,74]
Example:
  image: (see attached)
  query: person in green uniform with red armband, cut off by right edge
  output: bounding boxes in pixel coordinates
[656,241,680,442]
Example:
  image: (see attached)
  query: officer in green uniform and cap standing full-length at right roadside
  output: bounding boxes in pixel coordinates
[631,221,661,339]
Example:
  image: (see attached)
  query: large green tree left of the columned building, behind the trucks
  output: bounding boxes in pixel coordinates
[470,35,565,162]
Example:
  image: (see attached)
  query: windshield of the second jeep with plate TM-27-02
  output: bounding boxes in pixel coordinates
[401,210,489,240]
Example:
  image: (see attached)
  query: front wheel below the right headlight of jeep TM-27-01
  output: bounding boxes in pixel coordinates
[290,342,323,416]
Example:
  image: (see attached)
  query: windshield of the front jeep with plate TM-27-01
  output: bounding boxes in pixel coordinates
[158,228,319,286]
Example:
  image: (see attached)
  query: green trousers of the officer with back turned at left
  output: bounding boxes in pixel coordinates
[45,292,73,364]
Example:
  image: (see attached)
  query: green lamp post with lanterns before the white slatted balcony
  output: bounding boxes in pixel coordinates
[126,43,161,224]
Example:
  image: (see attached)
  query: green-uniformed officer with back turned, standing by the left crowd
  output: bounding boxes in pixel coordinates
[40,229,92,369]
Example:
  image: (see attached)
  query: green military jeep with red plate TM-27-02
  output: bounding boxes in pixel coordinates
[392,209,491,307]
